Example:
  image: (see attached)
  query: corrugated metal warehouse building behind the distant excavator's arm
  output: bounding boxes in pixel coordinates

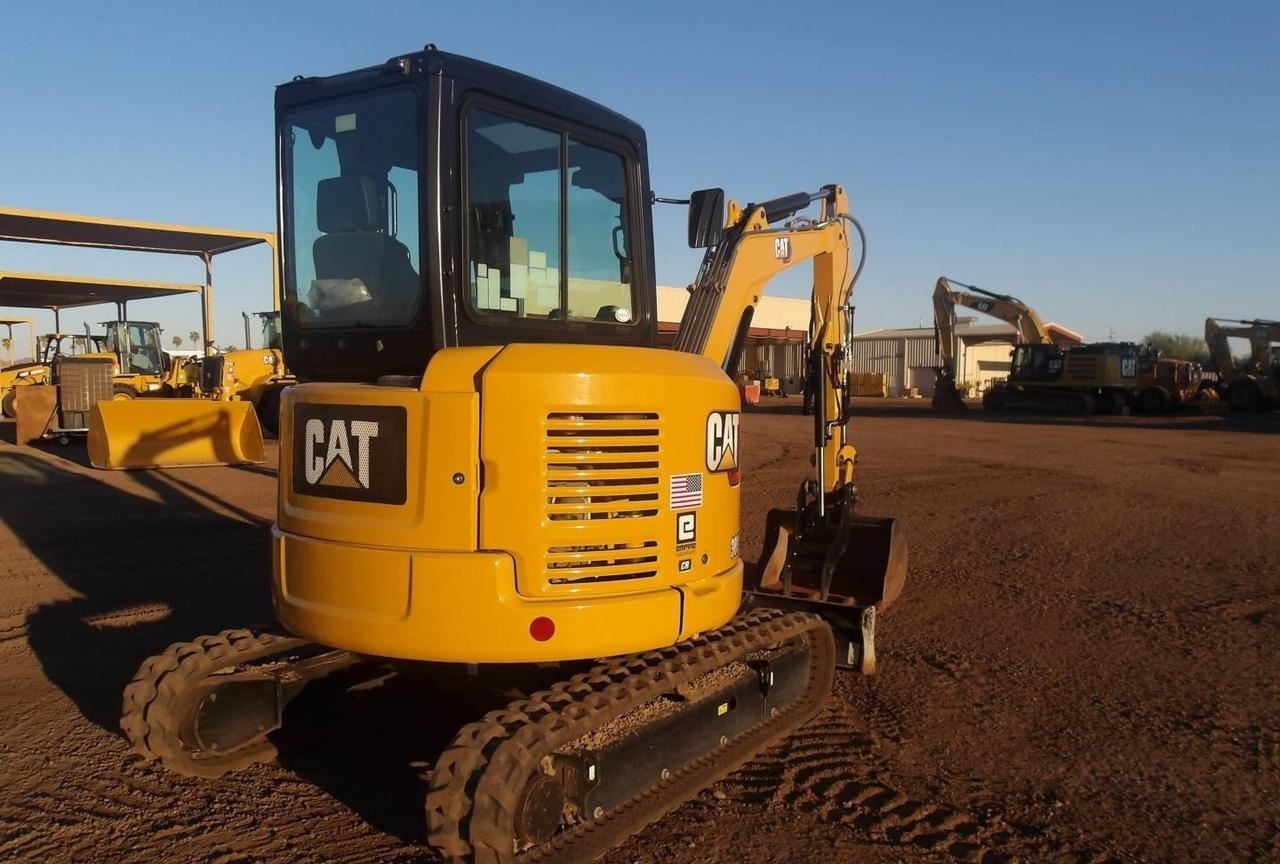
[852,319,1083,397]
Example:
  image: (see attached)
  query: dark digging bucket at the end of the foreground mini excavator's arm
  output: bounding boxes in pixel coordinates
[759,509,908,612]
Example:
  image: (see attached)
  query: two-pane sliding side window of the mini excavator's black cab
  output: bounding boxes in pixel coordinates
[466,109,634,324]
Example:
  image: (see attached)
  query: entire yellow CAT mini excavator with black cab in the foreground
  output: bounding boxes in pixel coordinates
[122,46,906,861]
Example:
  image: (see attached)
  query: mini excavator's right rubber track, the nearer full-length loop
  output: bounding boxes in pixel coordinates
[426,609,836,864]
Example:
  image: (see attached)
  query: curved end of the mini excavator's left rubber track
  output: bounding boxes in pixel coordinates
[120,630,307,777]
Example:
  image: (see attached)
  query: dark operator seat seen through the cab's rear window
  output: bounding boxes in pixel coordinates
[311,174,421,323]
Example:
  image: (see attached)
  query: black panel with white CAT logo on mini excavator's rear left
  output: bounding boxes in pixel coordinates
[293,404,406,504]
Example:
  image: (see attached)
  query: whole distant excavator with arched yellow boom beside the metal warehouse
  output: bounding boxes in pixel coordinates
[933,276,1143,413]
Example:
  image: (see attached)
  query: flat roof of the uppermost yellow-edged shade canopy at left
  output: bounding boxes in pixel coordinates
[0,207,275,257]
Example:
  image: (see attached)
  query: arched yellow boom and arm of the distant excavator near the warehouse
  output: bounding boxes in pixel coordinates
[933,276,1053,411]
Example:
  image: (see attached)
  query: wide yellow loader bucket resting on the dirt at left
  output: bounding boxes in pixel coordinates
[88,398,266,468]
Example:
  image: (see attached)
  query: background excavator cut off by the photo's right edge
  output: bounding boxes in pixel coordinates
[1204,317,1280,411]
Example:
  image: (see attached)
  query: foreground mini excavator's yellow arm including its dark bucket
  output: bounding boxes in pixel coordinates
[673,186,908,629]
